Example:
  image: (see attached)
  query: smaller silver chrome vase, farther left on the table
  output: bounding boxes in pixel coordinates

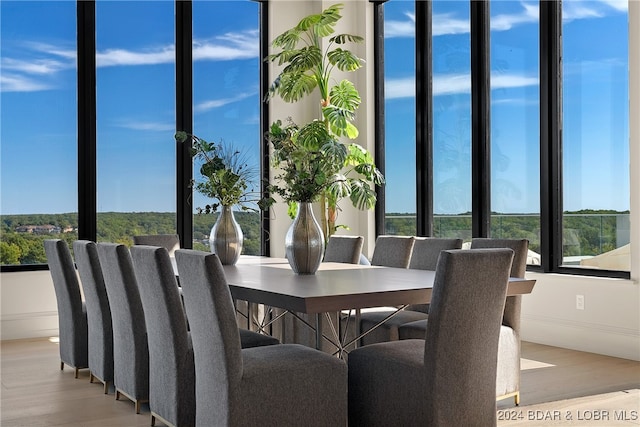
[209,206,244,265]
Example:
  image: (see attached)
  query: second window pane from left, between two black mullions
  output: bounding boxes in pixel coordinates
[96,0,176,243]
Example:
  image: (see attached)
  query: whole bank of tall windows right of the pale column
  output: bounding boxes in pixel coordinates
[378,0,630,277]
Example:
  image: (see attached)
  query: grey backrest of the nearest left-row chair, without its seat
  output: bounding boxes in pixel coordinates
[176,249,243,425]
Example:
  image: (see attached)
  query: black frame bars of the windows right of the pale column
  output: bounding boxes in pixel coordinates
[371,0,631,280]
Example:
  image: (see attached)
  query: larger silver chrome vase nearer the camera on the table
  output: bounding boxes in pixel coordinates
[284,203,324,274]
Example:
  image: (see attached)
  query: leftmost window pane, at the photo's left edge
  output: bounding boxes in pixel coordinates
[0,1,78,265]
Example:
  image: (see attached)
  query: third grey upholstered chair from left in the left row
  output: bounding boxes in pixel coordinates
[97,242,149,414]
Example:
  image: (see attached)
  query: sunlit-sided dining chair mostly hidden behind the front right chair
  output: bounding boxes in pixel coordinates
[398,238,529,405]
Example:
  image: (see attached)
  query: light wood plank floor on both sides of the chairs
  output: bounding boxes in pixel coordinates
[0,339,640,427]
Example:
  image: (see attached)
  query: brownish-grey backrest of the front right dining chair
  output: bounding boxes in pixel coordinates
[424,249,513,426]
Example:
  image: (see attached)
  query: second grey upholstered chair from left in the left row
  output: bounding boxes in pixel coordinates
[73,240,113,394]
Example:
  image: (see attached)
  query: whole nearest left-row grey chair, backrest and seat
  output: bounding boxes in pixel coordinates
[176,249,347,426]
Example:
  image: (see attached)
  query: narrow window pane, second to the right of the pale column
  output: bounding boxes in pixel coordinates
[431,0,471,240]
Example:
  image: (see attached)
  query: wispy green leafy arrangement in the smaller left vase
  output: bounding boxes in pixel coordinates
[175,131,268,214]
